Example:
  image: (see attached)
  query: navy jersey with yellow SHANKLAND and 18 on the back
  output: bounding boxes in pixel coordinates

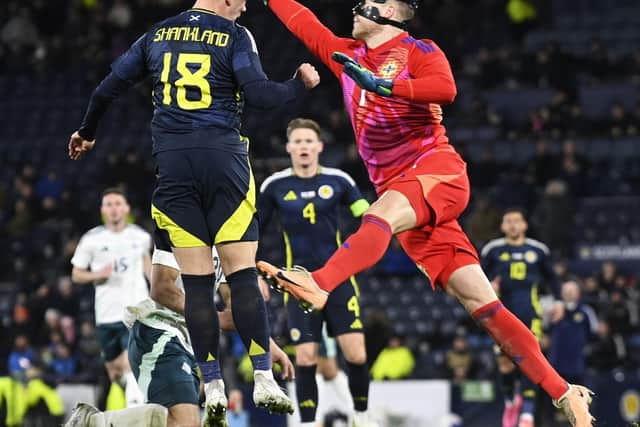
[112,9,266,152]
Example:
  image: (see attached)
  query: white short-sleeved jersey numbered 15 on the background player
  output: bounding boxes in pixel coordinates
[71,225,151,325]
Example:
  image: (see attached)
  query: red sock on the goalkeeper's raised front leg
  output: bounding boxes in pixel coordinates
[312,214,393,292]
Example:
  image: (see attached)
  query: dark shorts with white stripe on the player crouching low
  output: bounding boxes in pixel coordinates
[129,322,200,408]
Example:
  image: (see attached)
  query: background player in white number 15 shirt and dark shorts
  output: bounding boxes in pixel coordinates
[71,188,152,406]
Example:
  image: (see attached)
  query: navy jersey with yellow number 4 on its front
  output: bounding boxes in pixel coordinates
[258,166,369,270]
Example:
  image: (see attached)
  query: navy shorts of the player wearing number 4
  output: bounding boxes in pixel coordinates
[287,280,362,345]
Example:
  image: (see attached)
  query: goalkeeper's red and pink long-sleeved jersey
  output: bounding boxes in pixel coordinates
[269,0,456,192]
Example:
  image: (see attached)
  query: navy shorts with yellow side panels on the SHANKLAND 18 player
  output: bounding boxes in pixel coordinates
[151,139,258,248]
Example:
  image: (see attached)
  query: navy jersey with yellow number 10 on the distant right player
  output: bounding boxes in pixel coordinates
[481,238,559,321]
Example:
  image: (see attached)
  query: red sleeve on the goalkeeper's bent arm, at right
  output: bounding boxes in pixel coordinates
[392,41,457,104]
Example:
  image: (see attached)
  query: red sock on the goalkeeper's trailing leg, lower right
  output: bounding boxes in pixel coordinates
[472,300,568,399]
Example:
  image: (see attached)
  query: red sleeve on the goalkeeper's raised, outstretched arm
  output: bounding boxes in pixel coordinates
[269,0,354,75]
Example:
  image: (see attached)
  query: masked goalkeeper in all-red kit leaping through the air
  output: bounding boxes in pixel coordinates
[252,0,592,427]
